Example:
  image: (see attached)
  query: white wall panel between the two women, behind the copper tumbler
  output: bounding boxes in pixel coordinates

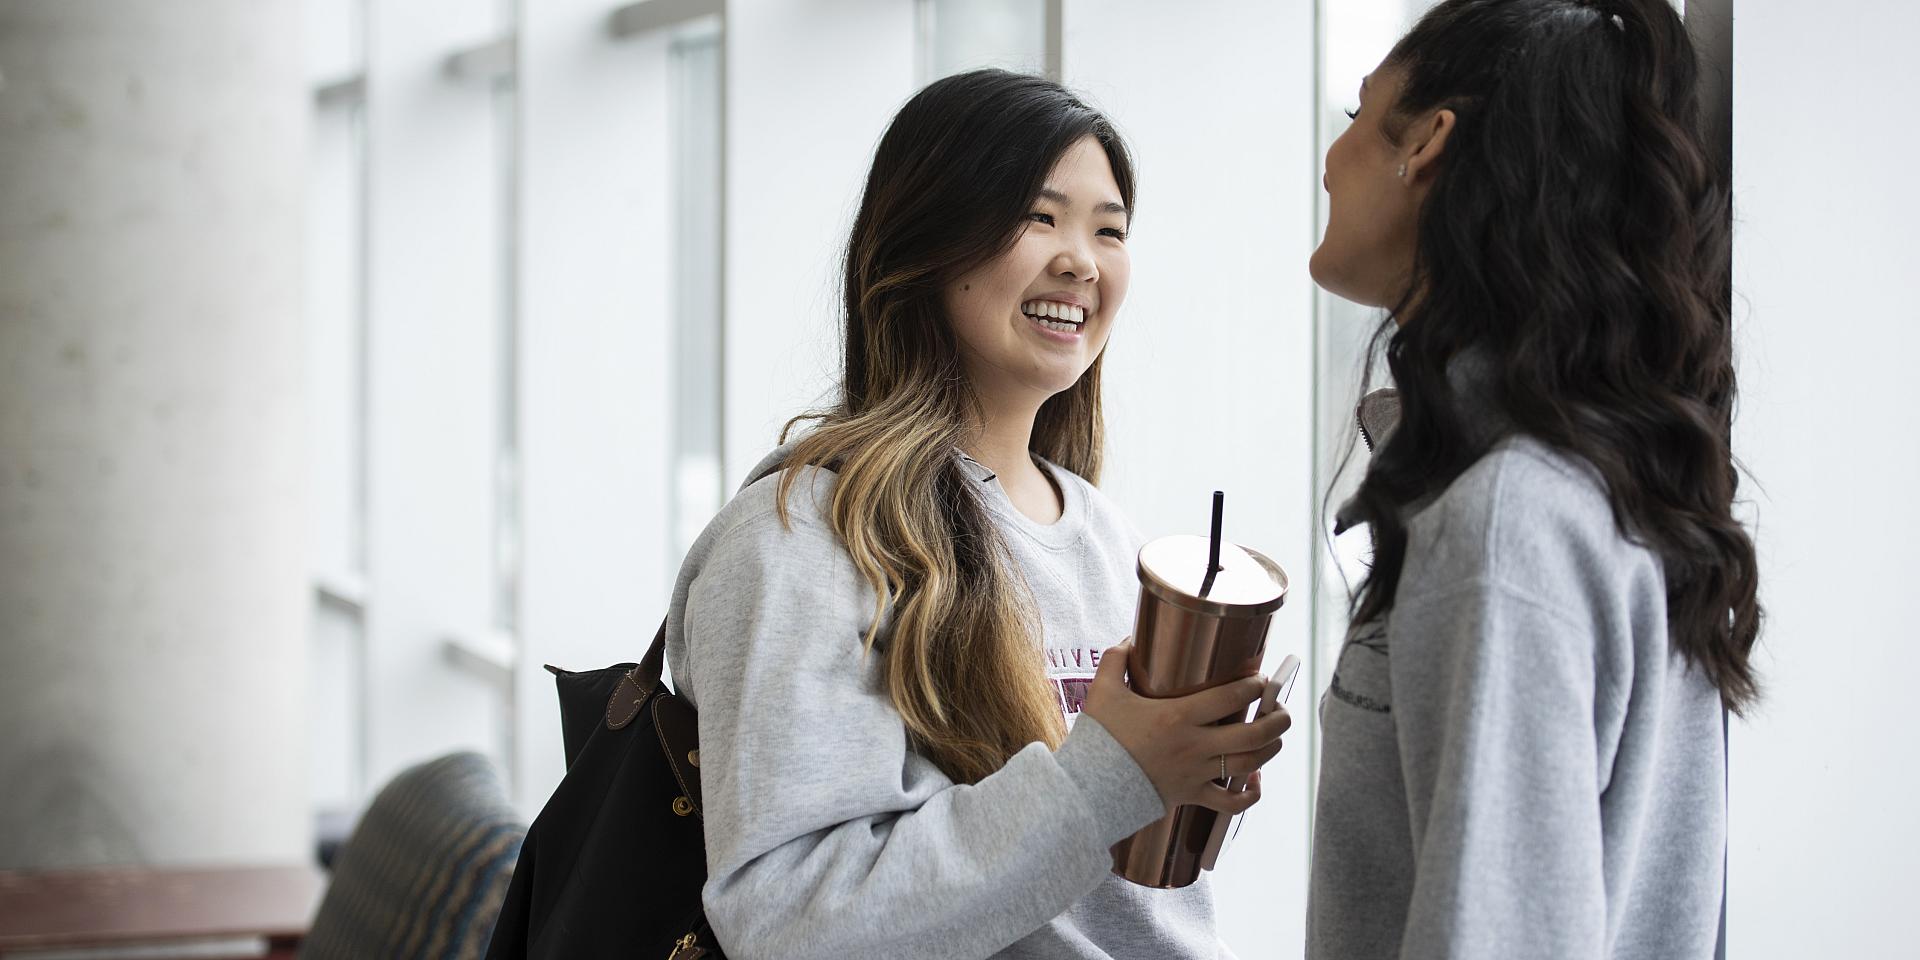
[1062,0,1319,960]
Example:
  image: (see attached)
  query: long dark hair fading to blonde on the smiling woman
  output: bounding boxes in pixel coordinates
[780,69,1133,781]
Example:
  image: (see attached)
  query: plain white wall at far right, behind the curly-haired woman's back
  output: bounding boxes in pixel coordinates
[1728,0,1920,958]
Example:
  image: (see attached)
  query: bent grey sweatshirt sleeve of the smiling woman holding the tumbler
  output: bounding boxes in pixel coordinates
[685,513,1164,960]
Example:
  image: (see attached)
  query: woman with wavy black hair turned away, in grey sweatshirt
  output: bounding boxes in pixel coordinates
[1308,0,1759,960]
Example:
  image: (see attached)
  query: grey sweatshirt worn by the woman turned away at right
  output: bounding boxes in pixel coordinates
[1308,430,1726,960]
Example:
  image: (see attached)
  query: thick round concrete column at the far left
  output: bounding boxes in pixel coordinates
[0,0,309,868]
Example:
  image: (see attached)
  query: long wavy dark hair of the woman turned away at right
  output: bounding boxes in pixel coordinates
[1354,0,1761,710]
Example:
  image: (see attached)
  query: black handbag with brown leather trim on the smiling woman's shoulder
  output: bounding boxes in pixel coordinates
[486,624,724,960]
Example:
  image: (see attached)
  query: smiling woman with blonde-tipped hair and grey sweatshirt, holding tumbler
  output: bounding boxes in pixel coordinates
[666,71,1288,960]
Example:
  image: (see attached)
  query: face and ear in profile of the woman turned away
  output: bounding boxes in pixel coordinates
[1308,65,1425,307]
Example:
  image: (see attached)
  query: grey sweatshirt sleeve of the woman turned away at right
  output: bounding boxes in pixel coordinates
[1388,578,1607,960]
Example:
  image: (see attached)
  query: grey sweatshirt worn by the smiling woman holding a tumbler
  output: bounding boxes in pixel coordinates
[666,451,1223,960]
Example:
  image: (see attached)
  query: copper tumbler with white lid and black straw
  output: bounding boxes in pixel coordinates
[1114,534,1286,889]
